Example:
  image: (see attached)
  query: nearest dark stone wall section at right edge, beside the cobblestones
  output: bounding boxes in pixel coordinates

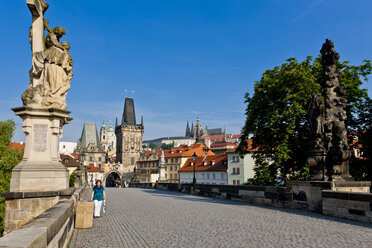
[322,190,372,223]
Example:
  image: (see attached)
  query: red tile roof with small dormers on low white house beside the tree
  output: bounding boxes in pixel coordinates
[179,154,227,172]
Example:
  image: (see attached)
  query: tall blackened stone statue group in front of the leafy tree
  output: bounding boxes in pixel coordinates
[307,39,351,181]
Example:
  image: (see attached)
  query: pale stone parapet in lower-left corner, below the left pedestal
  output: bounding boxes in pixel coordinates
[0,185,87,248]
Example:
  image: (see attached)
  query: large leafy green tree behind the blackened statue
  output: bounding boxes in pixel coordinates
[238,56,372,185]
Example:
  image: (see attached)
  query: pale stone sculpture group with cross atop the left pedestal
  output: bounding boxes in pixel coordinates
[22,0,73,110]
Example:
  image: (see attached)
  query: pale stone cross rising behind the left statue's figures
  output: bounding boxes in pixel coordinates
[26,0,49,53]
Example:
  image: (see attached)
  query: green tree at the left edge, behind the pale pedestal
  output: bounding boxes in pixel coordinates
[0,120,23,235]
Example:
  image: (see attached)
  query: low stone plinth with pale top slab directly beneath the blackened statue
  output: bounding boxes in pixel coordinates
[286,181,371,212]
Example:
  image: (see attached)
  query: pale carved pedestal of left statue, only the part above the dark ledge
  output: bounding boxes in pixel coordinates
[10,107,72,192]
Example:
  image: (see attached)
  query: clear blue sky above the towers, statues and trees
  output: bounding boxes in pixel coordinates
[0,0,372,141]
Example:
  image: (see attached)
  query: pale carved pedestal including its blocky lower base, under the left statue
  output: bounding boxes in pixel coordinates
[3,107,72,234]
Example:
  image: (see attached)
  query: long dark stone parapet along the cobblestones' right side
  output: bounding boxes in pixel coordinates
[153,181,372,222]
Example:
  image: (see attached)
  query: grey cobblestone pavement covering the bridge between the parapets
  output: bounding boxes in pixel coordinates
[70,188,372,248]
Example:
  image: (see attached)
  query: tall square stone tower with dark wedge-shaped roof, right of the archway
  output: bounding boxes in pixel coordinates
[115,97,144,172]
